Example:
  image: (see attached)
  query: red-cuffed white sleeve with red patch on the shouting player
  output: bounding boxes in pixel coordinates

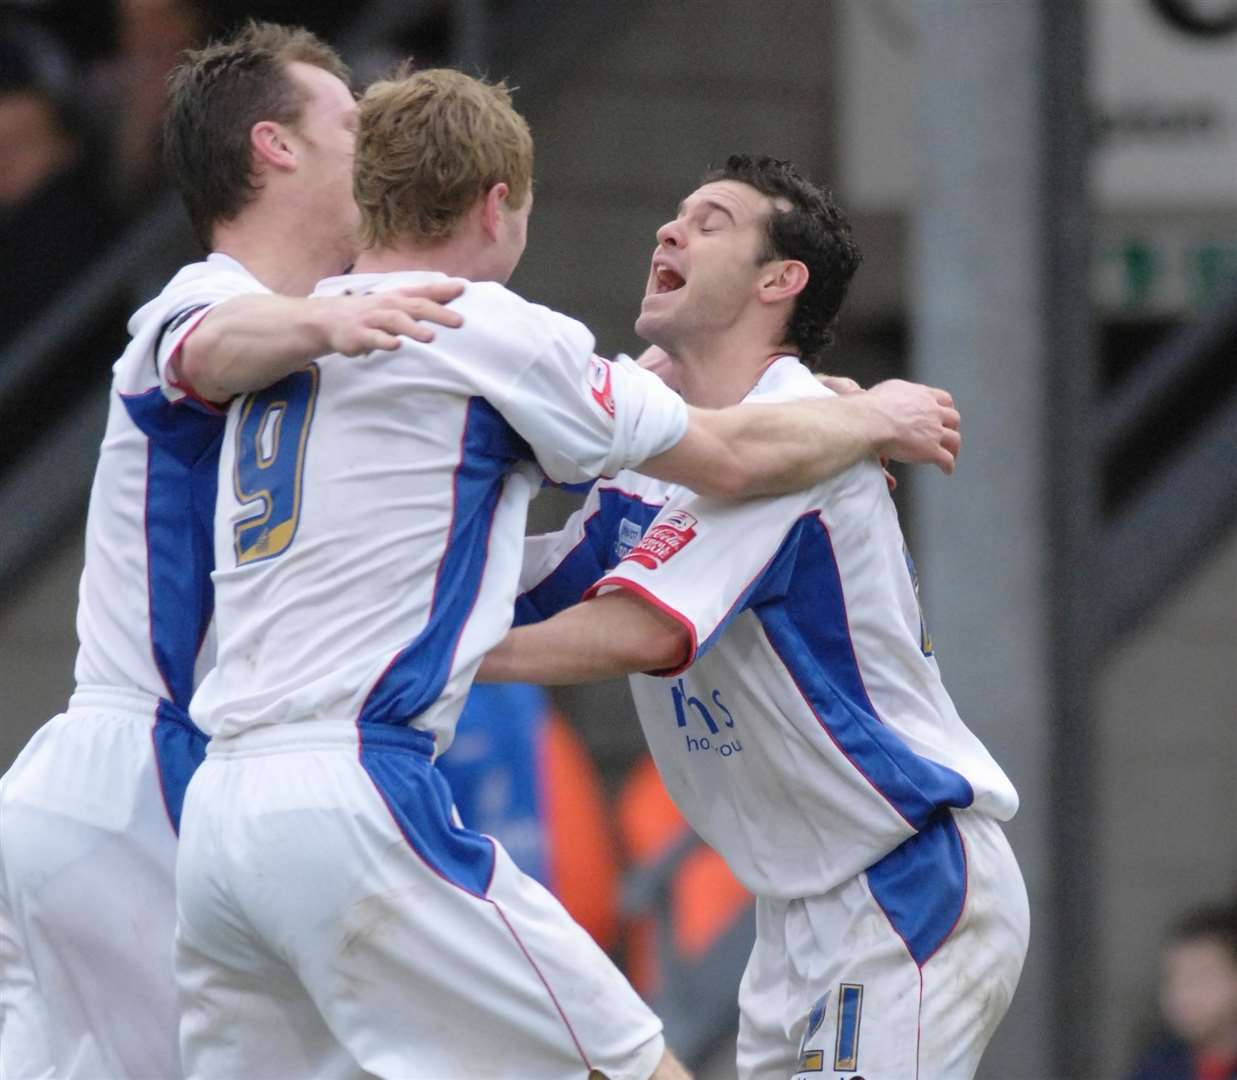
[585,490,815,675]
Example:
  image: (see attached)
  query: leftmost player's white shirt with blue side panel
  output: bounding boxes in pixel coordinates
[74,254,267,710]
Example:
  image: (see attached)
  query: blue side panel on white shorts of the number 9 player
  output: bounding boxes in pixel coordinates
[357,722,495,897]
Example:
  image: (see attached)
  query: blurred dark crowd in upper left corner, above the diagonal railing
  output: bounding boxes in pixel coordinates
[0,0,356,350]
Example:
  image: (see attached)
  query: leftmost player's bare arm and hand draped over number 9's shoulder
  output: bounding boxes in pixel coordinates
[167,281,464,402]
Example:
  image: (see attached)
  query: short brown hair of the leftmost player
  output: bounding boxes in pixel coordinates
[163,20,349,250]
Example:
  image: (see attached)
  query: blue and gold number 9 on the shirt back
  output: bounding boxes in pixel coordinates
[233,364,319,567]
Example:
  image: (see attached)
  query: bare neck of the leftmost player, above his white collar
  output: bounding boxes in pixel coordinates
[212,215,351,296]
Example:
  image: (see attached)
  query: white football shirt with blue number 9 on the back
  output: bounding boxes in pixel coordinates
[190,272,687,751]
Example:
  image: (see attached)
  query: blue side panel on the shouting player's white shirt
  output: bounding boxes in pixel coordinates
[742,512,975,829]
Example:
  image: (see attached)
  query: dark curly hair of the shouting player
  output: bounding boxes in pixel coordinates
[703,153,863,367]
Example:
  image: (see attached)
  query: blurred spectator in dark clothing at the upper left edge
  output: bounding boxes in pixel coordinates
[0,20,113,341]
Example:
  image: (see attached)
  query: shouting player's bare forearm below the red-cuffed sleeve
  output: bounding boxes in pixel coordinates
[477,590,691,687]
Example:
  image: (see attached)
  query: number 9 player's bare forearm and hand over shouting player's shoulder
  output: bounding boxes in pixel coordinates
[638,380,961,499]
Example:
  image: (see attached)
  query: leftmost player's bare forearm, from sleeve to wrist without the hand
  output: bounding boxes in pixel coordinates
[178,296,330,401]
